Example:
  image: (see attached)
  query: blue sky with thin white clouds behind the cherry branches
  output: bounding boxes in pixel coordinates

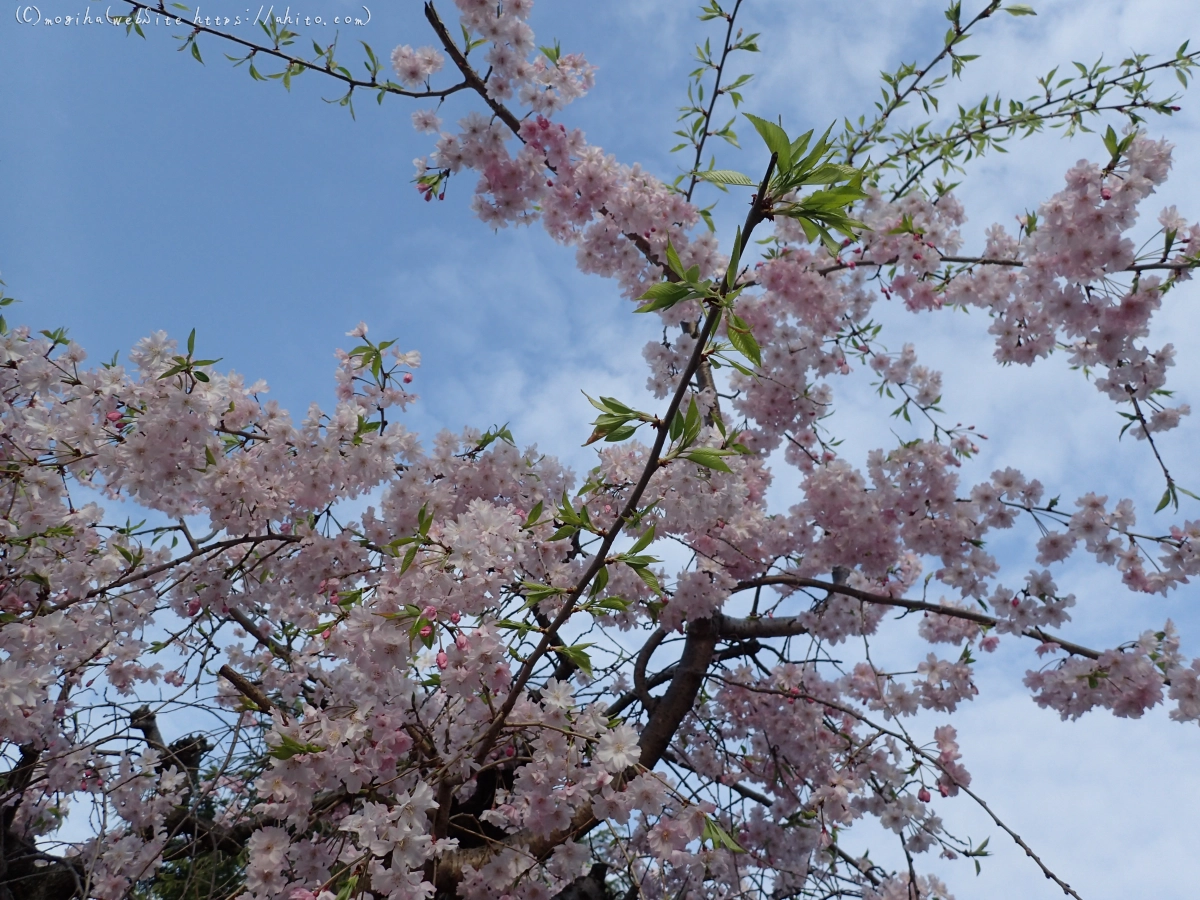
[0,0,1200,900]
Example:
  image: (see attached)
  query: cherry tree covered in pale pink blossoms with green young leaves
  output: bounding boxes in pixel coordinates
[7,0,1200,900]
